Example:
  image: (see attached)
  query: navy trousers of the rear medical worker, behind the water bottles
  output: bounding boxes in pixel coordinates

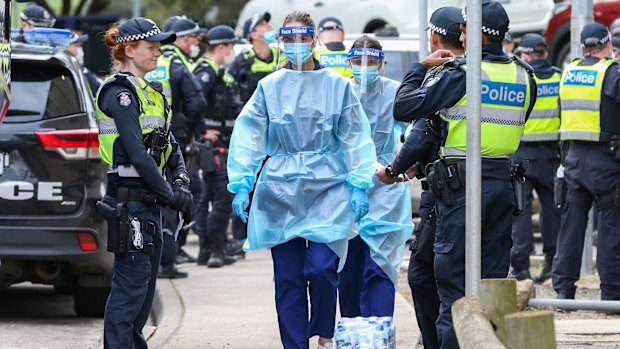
[338,236,396,317]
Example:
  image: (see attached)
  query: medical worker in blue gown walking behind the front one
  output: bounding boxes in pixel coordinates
[338,35,413,317]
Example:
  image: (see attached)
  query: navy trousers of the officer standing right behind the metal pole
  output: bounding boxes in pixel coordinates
[433,177,515,349]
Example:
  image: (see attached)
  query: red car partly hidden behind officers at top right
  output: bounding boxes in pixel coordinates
[545,0,620,67]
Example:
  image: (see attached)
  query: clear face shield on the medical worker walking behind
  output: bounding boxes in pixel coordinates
[348,47,384,94]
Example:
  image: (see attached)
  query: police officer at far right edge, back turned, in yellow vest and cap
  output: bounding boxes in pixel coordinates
[552,23,620,300]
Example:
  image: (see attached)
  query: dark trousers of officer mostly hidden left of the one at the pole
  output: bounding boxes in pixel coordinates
[407,190,439,349]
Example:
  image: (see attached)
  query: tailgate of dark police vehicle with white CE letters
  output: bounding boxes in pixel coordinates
[0,54,99,217]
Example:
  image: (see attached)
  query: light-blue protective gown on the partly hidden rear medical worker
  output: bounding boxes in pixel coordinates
[353,77,413,284]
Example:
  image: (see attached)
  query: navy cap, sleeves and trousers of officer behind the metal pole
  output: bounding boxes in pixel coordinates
[394,1,536,348]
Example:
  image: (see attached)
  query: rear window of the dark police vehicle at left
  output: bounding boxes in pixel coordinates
[4,61,82,123]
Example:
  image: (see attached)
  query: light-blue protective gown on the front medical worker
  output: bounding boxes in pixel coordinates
[228,69,376,265]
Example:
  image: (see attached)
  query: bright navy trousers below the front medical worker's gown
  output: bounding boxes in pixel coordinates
[271,238,339,349]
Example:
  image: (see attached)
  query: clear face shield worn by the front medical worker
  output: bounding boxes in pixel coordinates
[278,26,314,71]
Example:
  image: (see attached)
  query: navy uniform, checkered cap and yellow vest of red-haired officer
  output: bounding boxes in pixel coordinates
[97,18,191,348]
